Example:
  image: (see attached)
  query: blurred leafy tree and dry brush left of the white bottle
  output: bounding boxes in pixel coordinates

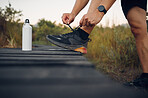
[0,3,22,47]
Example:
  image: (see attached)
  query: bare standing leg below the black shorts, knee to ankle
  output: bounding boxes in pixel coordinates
[127,7,148,73]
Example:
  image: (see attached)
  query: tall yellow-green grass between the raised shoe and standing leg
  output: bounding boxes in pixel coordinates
[86,26,141,82]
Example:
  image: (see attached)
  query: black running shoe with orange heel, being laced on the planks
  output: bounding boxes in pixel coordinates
[46,28,89,53]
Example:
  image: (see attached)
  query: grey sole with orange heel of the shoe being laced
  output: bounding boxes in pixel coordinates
[46,35,86,53]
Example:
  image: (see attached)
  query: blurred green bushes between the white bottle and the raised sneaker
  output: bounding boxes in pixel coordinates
[34,19,70,44]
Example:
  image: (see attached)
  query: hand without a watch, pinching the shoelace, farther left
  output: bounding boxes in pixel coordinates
[62,13,76,24]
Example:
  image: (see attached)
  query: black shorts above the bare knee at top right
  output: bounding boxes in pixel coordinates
[121,0,147,17]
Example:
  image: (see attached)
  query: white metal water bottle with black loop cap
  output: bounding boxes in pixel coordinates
[22,19,32,51]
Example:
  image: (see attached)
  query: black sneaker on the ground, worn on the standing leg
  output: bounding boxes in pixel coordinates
[124,76,148,89]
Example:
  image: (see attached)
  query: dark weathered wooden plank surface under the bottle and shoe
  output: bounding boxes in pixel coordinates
[0,46,148,98]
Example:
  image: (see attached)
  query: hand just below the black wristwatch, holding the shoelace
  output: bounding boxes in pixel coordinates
[79,9,104,27]
